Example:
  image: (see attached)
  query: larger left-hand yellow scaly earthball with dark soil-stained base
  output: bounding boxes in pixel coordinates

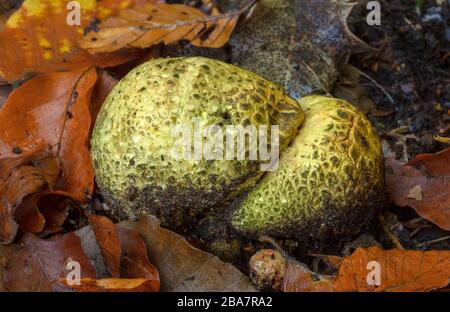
[92,57,304,228]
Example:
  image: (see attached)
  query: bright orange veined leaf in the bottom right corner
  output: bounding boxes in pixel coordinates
[335,247,450,292]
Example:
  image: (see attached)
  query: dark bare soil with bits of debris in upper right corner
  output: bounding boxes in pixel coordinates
[349,0,450,159]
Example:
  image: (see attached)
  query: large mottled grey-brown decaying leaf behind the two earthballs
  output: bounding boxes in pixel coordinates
[230,0,367,98]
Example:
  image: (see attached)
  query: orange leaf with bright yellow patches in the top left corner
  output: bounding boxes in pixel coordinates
[0,0,155,81]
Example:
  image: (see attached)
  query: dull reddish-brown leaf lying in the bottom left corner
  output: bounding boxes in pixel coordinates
[1,233,96,291]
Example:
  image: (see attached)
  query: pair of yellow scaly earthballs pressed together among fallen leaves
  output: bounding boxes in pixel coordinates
[91,57,384,239]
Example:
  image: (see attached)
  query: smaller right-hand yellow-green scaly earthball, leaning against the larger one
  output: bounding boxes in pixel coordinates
[232,96,385,239]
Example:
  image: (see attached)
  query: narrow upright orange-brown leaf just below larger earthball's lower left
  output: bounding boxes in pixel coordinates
[89,215,122,277]
